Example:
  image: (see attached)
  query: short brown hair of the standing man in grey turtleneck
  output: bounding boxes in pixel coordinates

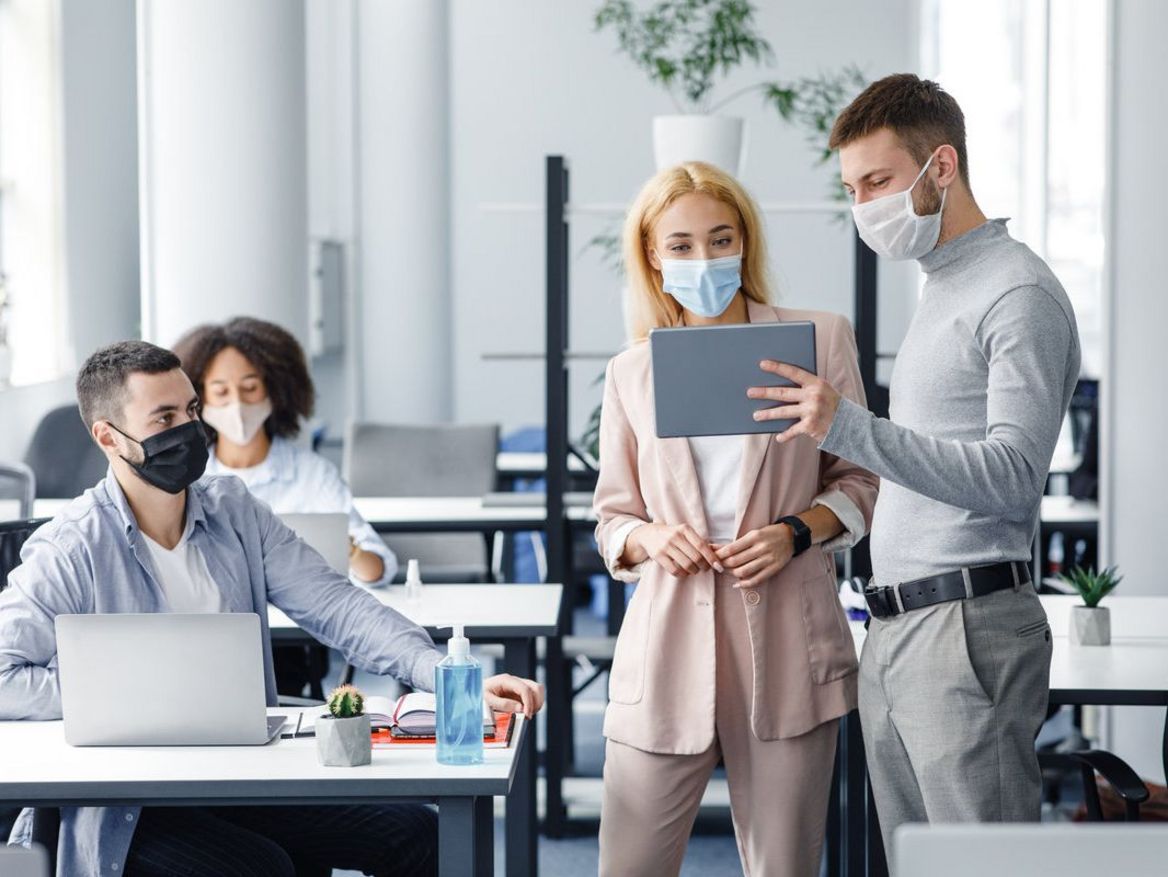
[827,74,969,188]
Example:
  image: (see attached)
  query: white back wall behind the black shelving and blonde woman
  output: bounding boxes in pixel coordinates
[450,0,917,436]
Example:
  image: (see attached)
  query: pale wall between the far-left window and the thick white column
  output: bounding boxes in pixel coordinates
[0,0,138,460]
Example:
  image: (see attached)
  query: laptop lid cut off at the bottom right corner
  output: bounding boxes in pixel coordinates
[894,822,1168,877]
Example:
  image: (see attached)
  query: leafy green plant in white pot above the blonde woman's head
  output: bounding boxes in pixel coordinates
[595,0,864,175]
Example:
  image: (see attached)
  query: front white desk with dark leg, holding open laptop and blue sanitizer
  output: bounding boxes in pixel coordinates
[0,710,527,877]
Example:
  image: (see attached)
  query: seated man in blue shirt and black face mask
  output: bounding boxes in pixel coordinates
[0,341,543,877]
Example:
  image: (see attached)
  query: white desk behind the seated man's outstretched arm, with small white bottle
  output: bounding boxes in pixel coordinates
[267,584,564,877]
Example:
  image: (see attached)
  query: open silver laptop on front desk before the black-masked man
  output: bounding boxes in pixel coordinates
[56,613,285,746]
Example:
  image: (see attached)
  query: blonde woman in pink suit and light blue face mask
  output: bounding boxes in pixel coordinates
[596,162,877,877]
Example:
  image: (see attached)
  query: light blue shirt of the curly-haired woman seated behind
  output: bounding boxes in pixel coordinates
[203,438,397,587]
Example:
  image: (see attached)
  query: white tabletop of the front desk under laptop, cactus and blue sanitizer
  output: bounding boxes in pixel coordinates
[0,708,524,805]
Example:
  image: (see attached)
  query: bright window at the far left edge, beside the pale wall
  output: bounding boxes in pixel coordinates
[0,0,70,387]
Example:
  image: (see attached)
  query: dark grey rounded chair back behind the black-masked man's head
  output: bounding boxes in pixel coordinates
[25,405,109,500]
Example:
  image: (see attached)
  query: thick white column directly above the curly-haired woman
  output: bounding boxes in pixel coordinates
[138,0,308,344]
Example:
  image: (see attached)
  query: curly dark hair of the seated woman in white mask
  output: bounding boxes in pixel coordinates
[173,316,317,441]
